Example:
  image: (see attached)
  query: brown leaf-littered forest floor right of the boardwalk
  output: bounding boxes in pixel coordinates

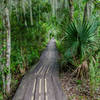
[60,72,100,100]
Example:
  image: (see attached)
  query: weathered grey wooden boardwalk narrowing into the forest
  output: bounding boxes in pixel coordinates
[13,39,68,100]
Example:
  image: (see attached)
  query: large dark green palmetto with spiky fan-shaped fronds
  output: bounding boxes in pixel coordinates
[65,22,98,61]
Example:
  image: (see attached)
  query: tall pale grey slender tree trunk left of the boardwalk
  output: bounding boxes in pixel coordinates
[4,7,11,94]
